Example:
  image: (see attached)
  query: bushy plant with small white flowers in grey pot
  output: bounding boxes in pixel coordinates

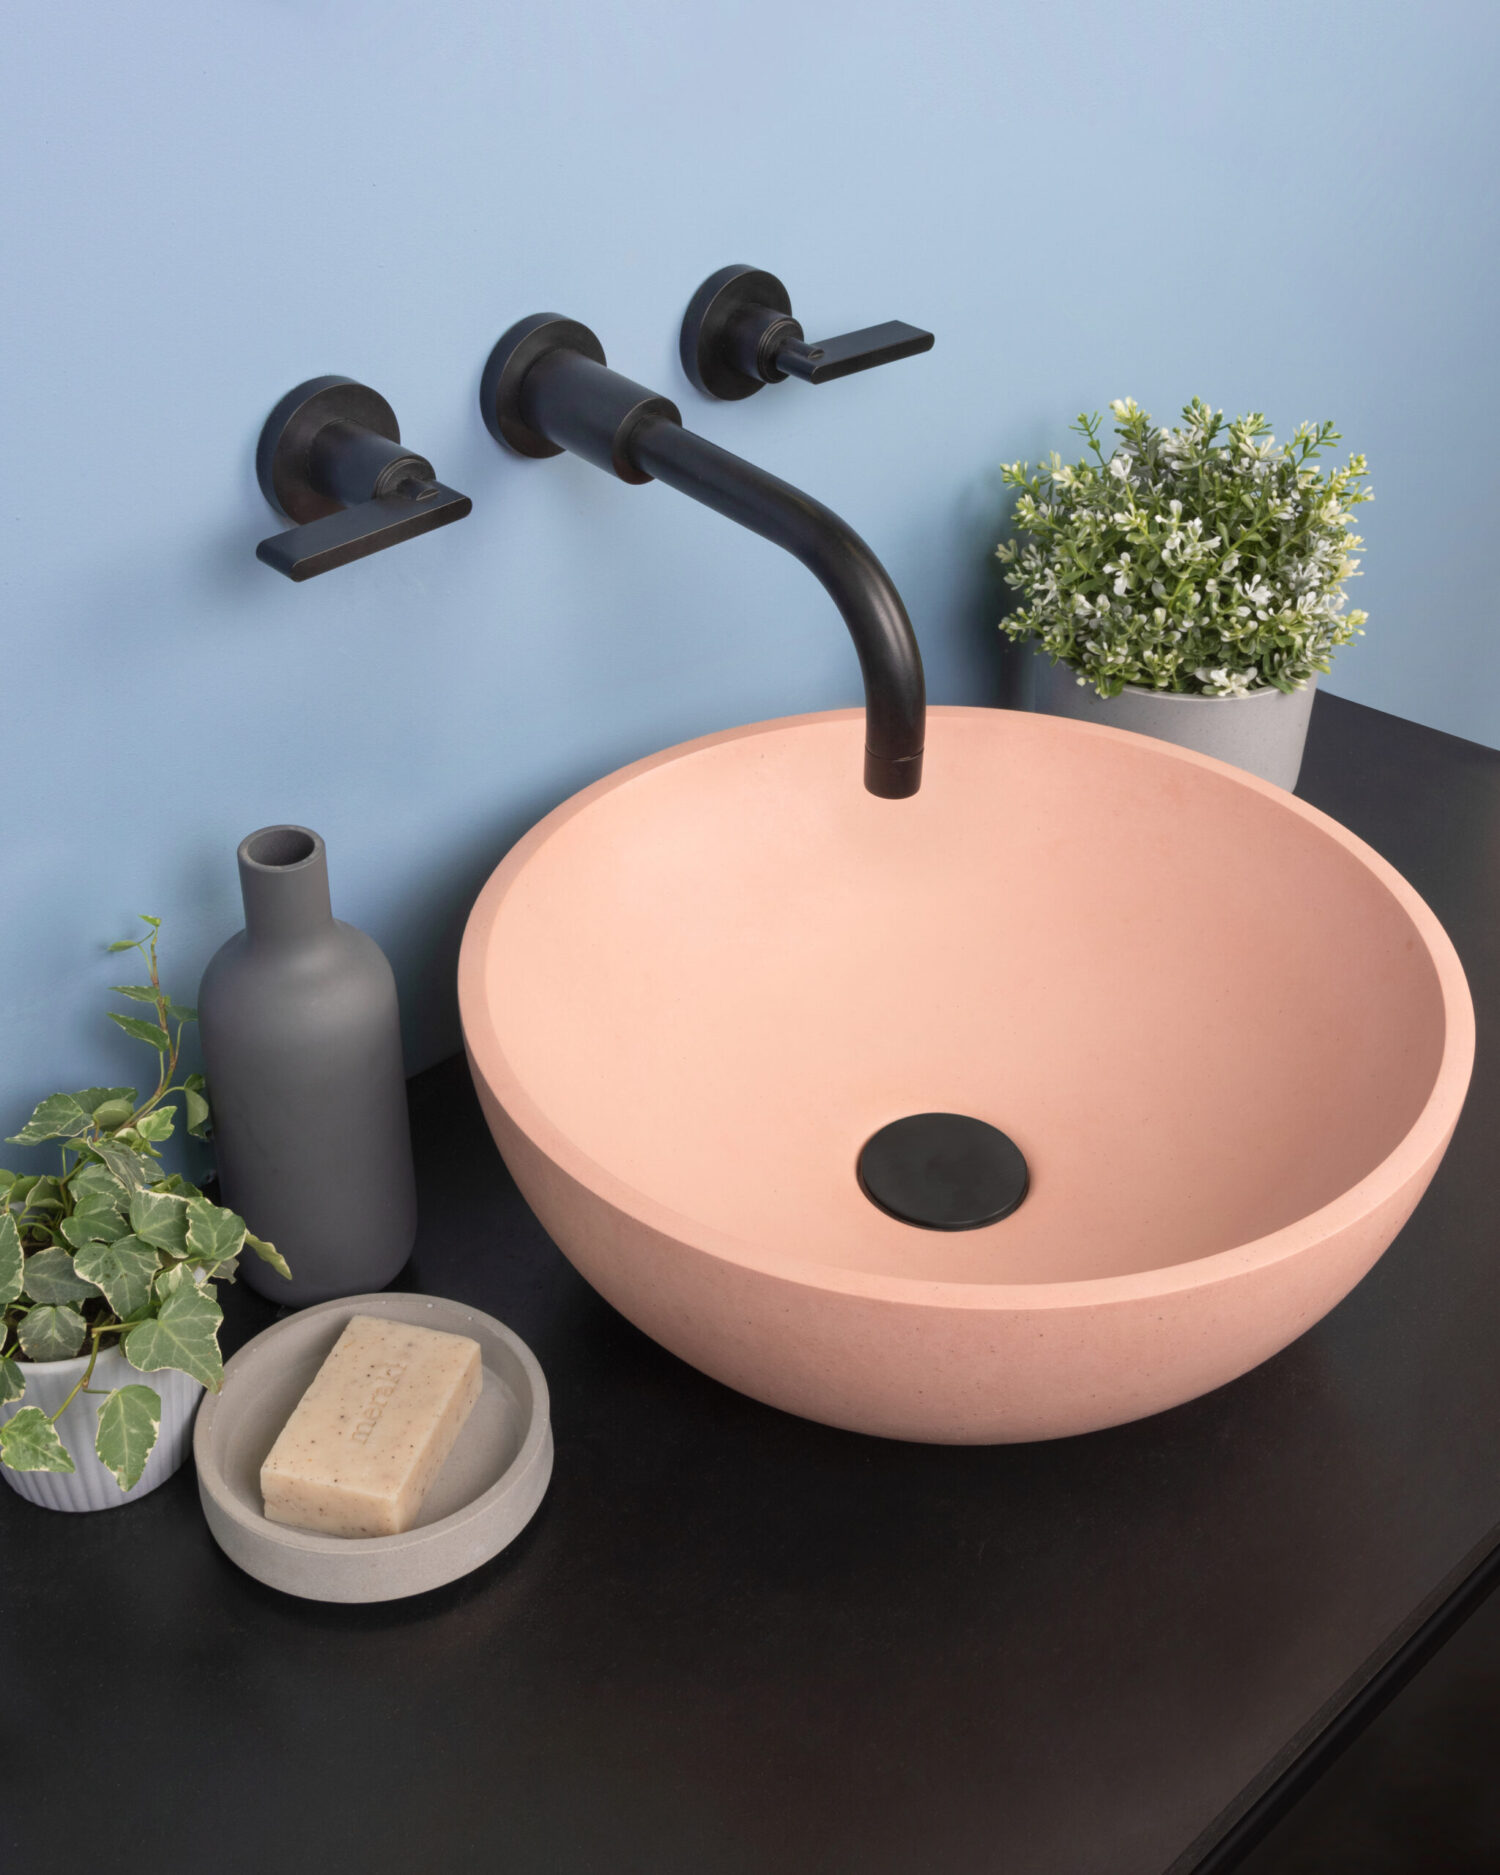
[998,398,1371,788]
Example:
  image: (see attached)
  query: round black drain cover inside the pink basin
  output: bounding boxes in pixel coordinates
[859,1114,1029,1230]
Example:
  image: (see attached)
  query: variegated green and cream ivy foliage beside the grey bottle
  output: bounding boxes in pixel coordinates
[0,913,291,1491]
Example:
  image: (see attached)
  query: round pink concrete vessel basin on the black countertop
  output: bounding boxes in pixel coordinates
[459,709,1474,1442]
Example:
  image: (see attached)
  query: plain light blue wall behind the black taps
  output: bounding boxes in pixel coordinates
[0,0,1500,1131]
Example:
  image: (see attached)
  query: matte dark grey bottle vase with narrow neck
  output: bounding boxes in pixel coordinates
[199,827,416,1307]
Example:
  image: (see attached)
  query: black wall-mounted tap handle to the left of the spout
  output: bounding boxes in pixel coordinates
[255,377,473,579]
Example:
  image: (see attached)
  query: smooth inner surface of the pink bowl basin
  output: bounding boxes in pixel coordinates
[478,711,1466,1284]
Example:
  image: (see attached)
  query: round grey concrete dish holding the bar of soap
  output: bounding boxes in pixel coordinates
[193,1292,551,1601]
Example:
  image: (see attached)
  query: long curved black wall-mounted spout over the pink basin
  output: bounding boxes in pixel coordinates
[480,313,930,801]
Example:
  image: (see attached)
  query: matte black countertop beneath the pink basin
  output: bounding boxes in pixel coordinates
[0,696,1500,1875]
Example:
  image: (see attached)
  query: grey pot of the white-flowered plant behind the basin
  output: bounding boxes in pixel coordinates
[1018,647,1316,789]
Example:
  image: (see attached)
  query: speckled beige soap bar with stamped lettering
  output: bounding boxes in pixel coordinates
[261,1314,484,1536]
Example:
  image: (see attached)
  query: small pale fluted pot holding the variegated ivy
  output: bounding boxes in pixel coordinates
[0,1348,203,1511]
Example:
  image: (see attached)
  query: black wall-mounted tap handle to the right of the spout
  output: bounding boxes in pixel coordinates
[681,266,932,398]
